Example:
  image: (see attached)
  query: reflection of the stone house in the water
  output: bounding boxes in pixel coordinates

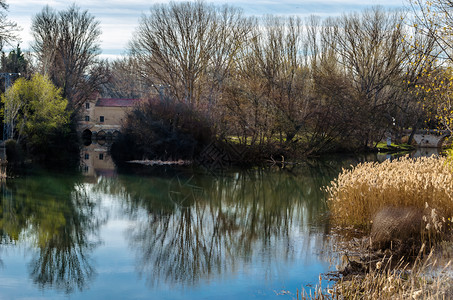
[80,143,116,178]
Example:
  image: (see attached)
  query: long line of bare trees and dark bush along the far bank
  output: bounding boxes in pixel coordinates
[0,0,449,164]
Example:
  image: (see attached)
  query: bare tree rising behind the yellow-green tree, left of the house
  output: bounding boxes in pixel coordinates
[31,5,106,108]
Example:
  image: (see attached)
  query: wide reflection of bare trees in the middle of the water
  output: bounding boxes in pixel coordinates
[107,162,348,284]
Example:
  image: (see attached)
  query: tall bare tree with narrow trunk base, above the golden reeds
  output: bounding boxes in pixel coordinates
[329,7,407,147]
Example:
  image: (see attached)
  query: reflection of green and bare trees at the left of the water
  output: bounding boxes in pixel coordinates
[0,174,102,293]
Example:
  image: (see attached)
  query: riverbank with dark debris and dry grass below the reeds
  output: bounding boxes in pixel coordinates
[296,236,453,300]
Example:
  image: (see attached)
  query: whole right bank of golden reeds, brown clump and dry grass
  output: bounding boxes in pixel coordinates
[306,156,453,299]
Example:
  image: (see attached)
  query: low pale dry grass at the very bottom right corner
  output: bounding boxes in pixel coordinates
[297,248,453,300]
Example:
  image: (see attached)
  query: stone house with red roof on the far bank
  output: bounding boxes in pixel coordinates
[78,97,141,139]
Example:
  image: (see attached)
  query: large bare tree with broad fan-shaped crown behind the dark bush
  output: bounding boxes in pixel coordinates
[130,1,247,106]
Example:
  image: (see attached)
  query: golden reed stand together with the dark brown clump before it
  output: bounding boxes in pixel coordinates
[326,156,453,256]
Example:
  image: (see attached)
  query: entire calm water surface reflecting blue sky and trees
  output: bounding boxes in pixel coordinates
[0,145,412,299]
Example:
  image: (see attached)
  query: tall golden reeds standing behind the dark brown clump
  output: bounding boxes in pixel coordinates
[326,156,453,228]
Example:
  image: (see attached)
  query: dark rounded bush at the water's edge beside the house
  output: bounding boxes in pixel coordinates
[112,98,212,160]
